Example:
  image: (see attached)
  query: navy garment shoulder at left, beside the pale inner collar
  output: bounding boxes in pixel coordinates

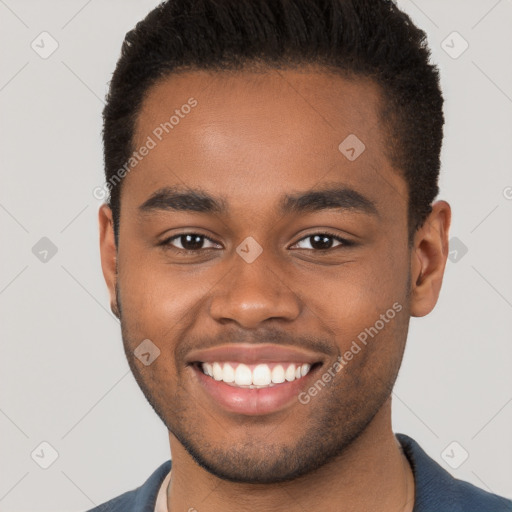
[87,460,171,512]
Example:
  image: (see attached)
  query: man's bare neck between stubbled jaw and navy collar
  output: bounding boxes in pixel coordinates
[167,398,414,512]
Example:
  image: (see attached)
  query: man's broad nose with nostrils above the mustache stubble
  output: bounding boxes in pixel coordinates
[210,252,301,329]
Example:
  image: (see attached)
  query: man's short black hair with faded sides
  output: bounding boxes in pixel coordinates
[103,0,444,244]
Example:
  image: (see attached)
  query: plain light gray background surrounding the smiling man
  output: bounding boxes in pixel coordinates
[0,0,512,512]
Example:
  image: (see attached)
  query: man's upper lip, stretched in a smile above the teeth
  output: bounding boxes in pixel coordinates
[186,343,322,364]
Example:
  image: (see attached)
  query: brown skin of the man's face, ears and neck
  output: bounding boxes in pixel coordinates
[99,70,451,512]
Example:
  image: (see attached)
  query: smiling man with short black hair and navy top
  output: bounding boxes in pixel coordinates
[93,0,512,512]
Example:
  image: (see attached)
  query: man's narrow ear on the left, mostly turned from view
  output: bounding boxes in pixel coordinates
[98,204,119,318]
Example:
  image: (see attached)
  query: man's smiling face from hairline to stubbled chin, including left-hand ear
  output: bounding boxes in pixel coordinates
[100,71,440,483]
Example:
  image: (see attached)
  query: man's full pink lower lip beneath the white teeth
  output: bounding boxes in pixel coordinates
[192,365,317,416]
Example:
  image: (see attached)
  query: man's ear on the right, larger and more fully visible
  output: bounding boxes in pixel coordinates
[411,201,452,317]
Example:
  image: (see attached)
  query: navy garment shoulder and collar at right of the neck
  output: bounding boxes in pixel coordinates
[395,434,512,512]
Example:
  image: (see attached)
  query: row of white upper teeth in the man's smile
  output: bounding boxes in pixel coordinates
[201,362,311,387]
